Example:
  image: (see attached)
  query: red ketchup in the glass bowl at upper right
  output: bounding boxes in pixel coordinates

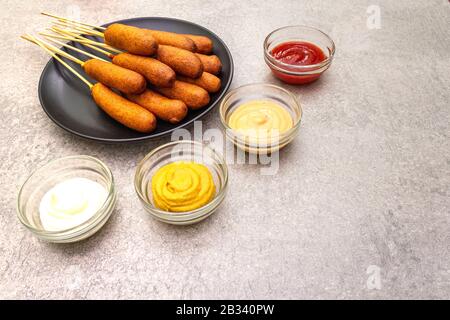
[270,41,327,84]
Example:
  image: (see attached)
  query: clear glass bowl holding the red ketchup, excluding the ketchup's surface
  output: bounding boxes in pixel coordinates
[264,26,336,84]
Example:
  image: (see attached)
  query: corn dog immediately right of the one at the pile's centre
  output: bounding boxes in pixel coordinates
[157,45,203,78]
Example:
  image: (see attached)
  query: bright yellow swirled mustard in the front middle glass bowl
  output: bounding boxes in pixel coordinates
[152,161,216,212]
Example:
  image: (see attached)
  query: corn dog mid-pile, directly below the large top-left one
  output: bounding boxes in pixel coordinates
[112,53,175,87]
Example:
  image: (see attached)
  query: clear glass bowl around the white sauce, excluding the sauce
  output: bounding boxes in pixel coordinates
[17,155,117,243]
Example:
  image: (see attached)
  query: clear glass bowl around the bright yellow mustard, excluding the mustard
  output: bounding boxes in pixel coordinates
[134,140,228,225]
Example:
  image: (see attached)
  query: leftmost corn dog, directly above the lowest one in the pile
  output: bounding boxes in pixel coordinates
[82,59,147,93]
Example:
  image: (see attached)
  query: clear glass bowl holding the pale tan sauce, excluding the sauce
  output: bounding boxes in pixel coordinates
[220,83,302,154]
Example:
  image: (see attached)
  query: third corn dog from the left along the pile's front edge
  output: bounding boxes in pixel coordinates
[156,80,209,110]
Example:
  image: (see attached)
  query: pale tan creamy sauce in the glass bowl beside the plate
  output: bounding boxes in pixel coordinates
[228,100,293,140]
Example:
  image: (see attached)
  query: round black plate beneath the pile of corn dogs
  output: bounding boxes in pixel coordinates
[39,17,233,142]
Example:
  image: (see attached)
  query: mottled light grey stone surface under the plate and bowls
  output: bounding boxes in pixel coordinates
[0,0,450,299]
